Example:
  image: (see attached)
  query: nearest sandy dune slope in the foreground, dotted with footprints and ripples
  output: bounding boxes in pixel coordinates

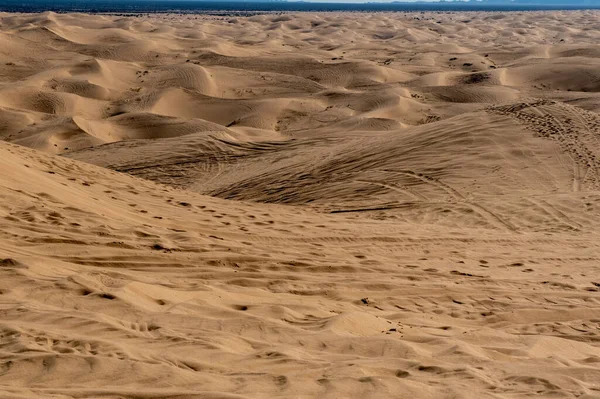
[0,129,600,398]
